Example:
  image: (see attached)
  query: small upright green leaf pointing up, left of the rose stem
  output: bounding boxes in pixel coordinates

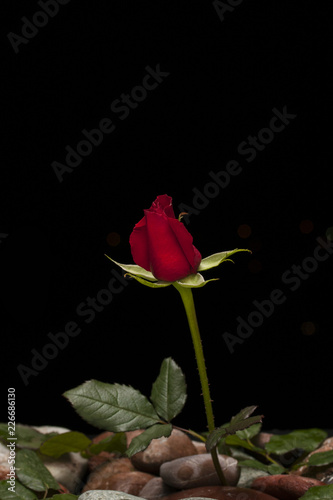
[150,358,187,422]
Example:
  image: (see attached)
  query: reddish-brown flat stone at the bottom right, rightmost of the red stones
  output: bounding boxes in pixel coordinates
[251,474,325,500]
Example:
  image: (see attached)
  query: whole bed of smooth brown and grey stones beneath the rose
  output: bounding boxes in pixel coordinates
[0,427,333,500]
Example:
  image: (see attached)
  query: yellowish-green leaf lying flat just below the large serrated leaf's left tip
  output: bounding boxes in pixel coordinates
[40,431,91,458]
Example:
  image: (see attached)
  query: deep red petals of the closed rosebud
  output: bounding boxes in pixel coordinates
[130,194,201,281]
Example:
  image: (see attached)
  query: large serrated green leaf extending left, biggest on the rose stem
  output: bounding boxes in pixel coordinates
[64,380,160,432]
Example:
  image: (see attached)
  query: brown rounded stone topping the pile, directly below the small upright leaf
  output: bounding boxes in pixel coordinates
[131,429,197,475]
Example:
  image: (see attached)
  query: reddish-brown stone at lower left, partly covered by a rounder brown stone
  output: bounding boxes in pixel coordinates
[82,457,134,492]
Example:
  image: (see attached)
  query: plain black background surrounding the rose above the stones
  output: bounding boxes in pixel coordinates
[0,0,333,432]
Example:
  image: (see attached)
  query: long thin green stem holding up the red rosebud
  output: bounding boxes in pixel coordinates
[173,283,227,486]
